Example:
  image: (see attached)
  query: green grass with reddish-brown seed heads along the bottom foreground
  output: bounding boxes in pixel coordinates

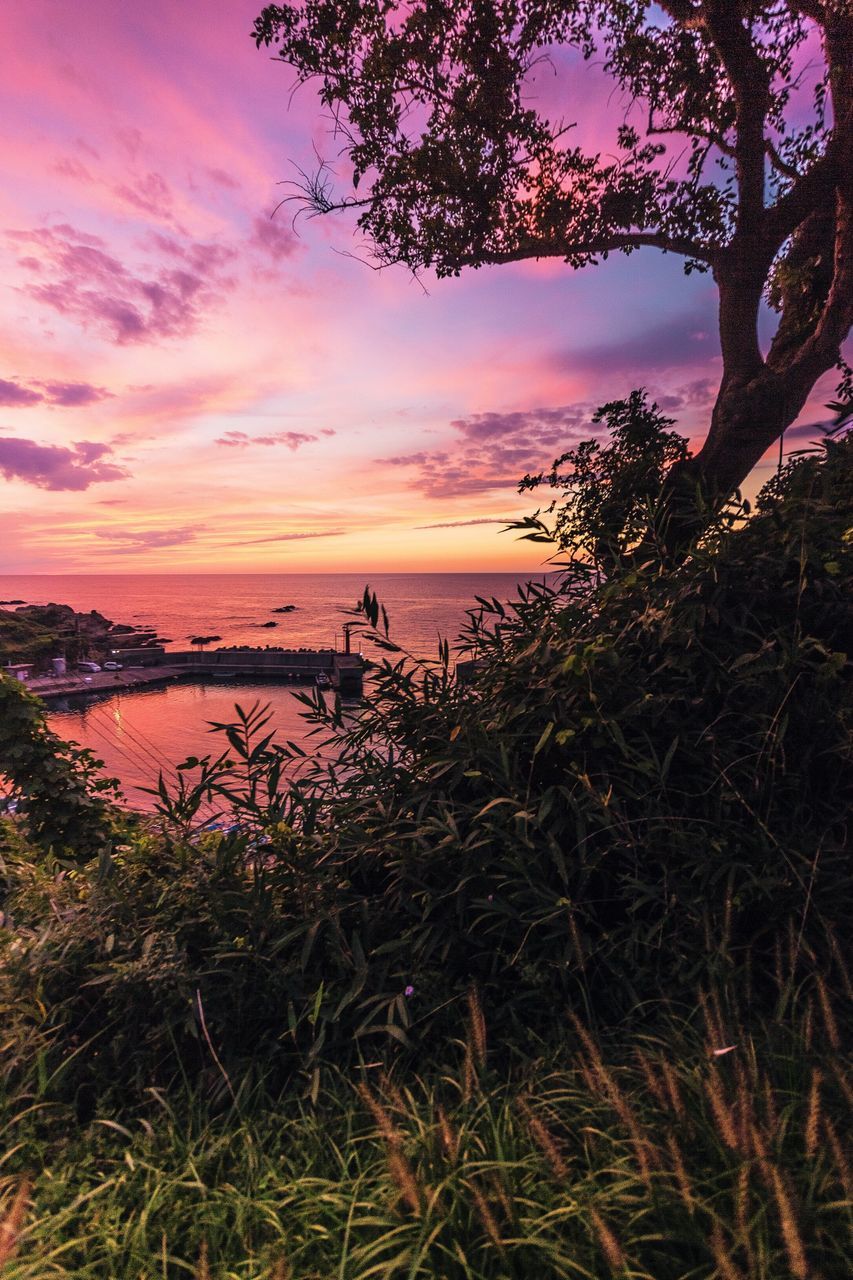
[0,962,853,1280]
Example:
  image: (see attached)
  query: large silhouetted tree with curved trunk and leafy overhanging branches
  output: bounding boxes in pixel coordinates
[254,0,853,502]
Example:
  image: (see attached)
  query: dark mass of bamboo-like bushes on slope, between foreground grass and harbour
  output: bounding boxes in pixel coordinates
[6,438,853,1111]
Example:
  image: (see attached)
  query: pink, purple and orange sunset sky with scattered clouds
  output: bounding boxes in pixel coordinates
[0,0,833,573]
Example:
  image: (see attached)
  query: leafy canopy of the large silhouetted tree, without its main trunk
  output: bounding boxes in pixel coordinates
[255,0,833,274]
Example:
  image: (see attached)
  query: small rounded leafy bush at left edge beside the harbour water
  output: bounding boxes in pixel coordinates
[0,673,118,861]
